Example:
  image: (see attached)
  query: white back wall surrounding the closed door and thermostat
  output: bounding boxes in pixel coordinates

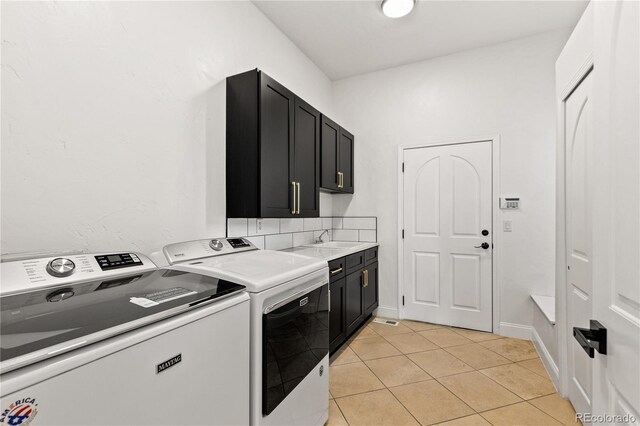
[333,30,569,332]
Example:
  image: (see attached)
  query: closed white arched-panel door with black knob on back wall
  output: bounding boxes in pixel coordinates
[402,141,493,331]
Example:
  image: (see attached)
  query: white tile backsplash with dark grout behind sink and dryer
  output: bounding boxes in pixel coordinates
[227,216,378,250]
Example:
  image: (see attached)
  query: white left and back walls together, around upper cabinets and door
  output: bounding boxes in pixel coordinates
[1,2,568,332]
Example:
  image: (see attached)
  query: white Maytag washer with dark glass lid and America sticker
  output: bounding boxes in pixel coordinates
[0,253,249,425]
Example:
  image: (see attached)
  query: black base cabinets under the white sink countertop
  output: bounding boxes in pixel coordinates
[329,247,379,353]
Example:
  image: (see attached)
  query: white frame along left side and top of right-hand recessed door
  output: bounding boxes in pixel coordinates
[556,3,595,398]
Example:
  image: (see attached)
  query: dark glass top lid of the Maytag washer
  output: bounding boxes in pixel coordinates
[0,269,244,373]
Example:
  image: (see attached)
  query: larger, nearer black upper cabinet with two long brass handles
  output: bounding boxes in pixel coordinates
[226,70,321,217]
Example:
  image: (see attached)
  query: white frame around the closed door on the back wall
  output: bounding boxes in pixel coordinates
[396,134,508,333]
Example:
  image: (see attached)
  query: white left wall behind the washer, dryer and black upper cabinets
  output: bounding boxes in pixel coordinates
[1,2,332,253]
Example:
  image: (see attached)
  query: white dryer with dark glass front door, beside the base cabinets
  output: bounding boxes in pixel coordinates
[163,238,329,426]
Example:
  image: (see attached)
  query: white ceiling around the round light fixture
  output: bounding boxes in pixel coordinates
[253,0,587,80]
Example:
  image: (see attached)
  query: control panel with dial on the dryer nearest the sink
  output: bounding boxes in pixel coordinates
[162,238,258,265]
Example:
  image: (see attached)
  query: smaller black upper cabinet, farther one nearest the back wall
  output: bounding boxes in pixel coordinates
[320,115,354,194]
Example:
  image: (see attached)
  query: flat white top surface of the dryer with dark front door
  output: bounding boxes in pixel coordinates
[170,250,328,293]
